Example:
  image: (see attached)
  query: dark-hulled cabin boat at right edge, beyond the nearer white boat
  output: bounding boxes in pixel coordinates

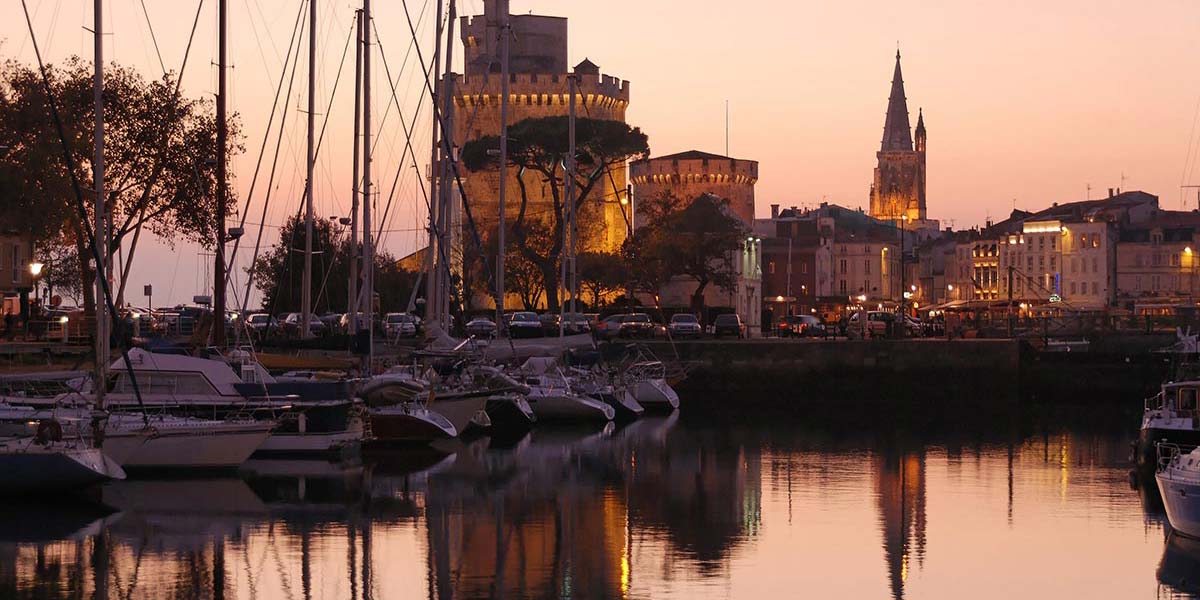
[1135,379,1200,474]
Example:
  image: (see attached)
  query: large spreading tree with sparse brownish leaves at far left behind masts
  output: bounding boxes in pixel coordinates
[0,58,242,312]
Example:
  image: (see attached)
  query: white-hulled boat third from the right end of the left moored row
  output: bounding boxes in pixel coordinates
[517,356,617,421]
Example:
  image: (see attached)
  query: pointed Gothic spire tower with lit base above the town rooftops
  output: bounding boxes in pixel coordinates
[871,50,925,228]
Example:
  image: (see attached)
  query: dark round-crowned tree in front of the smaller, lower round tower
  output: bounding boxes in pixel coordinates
[626,193,746,311]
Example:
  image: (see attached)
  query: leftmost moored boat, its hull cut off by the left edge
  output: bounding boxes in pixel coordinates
[0,434,125,496]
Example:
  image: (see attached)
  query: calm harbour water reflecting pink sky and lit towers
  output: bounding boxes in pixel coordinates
[0,416,1185,600]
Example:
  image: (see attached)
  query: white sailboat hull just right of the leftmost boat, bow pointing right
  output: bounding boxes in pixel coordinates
[103,421,272,469]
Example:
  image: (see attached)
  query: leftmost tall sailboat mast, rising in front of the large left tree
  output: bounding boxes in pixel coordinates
[91,0,110,408]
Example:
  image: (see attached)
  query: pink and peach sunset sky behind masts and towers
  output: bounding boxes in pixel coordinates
[0,0,1200,306]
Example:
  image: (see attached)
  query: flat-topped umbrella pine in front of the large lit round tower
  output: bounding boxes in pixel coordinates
[462,116,649,312]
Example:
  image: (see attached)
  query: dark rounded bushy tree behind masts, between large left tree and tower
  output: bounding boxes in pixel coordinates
[247,215,416,314]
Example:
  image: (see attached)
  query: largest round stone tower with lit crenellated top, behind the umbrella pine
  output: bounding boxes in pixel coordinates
[454,0,630,252]
